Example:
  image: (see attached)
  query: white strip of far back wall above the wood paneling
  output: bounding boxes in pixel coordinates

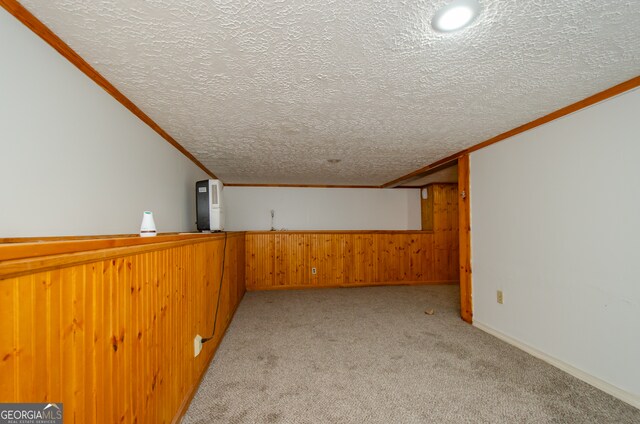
[224,187,421,230]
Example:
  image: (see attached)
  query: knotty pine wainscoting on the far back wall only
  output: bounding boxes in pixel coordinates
[246,231,458,290]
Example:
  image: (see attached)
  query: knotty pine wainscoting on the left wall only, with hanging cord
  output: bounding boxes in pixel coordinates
[0,233,245,423]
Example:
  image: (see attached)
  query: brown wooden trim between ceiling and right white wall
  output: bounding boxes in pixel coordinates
[381,76,640,188]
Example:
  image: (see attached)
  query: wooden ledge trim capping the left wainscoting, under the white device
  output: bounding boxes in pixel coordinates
[0,232,244,272]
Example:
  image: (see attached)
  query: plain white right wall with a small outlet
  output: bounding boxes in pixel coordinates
[471,90,640,405]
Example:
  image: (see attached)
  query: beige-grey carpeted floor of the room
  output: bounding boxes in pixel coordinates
[183,286,640,424]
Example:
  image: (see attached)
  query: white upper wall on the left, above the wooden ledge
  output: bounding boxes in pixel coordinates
[0,8,207,237]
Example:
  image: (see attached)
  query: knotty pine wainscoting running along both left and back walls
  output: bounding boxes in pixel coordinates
[0,231,457,423]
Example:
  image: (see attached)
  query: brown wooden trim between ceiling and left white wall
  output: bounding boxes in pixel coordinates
[0,0,217,178]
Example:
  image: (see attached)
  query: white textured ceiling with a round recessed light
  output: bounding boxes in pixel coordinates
[21,0,640,185]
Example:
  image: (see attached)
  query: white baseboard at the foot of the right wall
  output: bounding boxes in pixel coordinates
[473,320,640,409]
